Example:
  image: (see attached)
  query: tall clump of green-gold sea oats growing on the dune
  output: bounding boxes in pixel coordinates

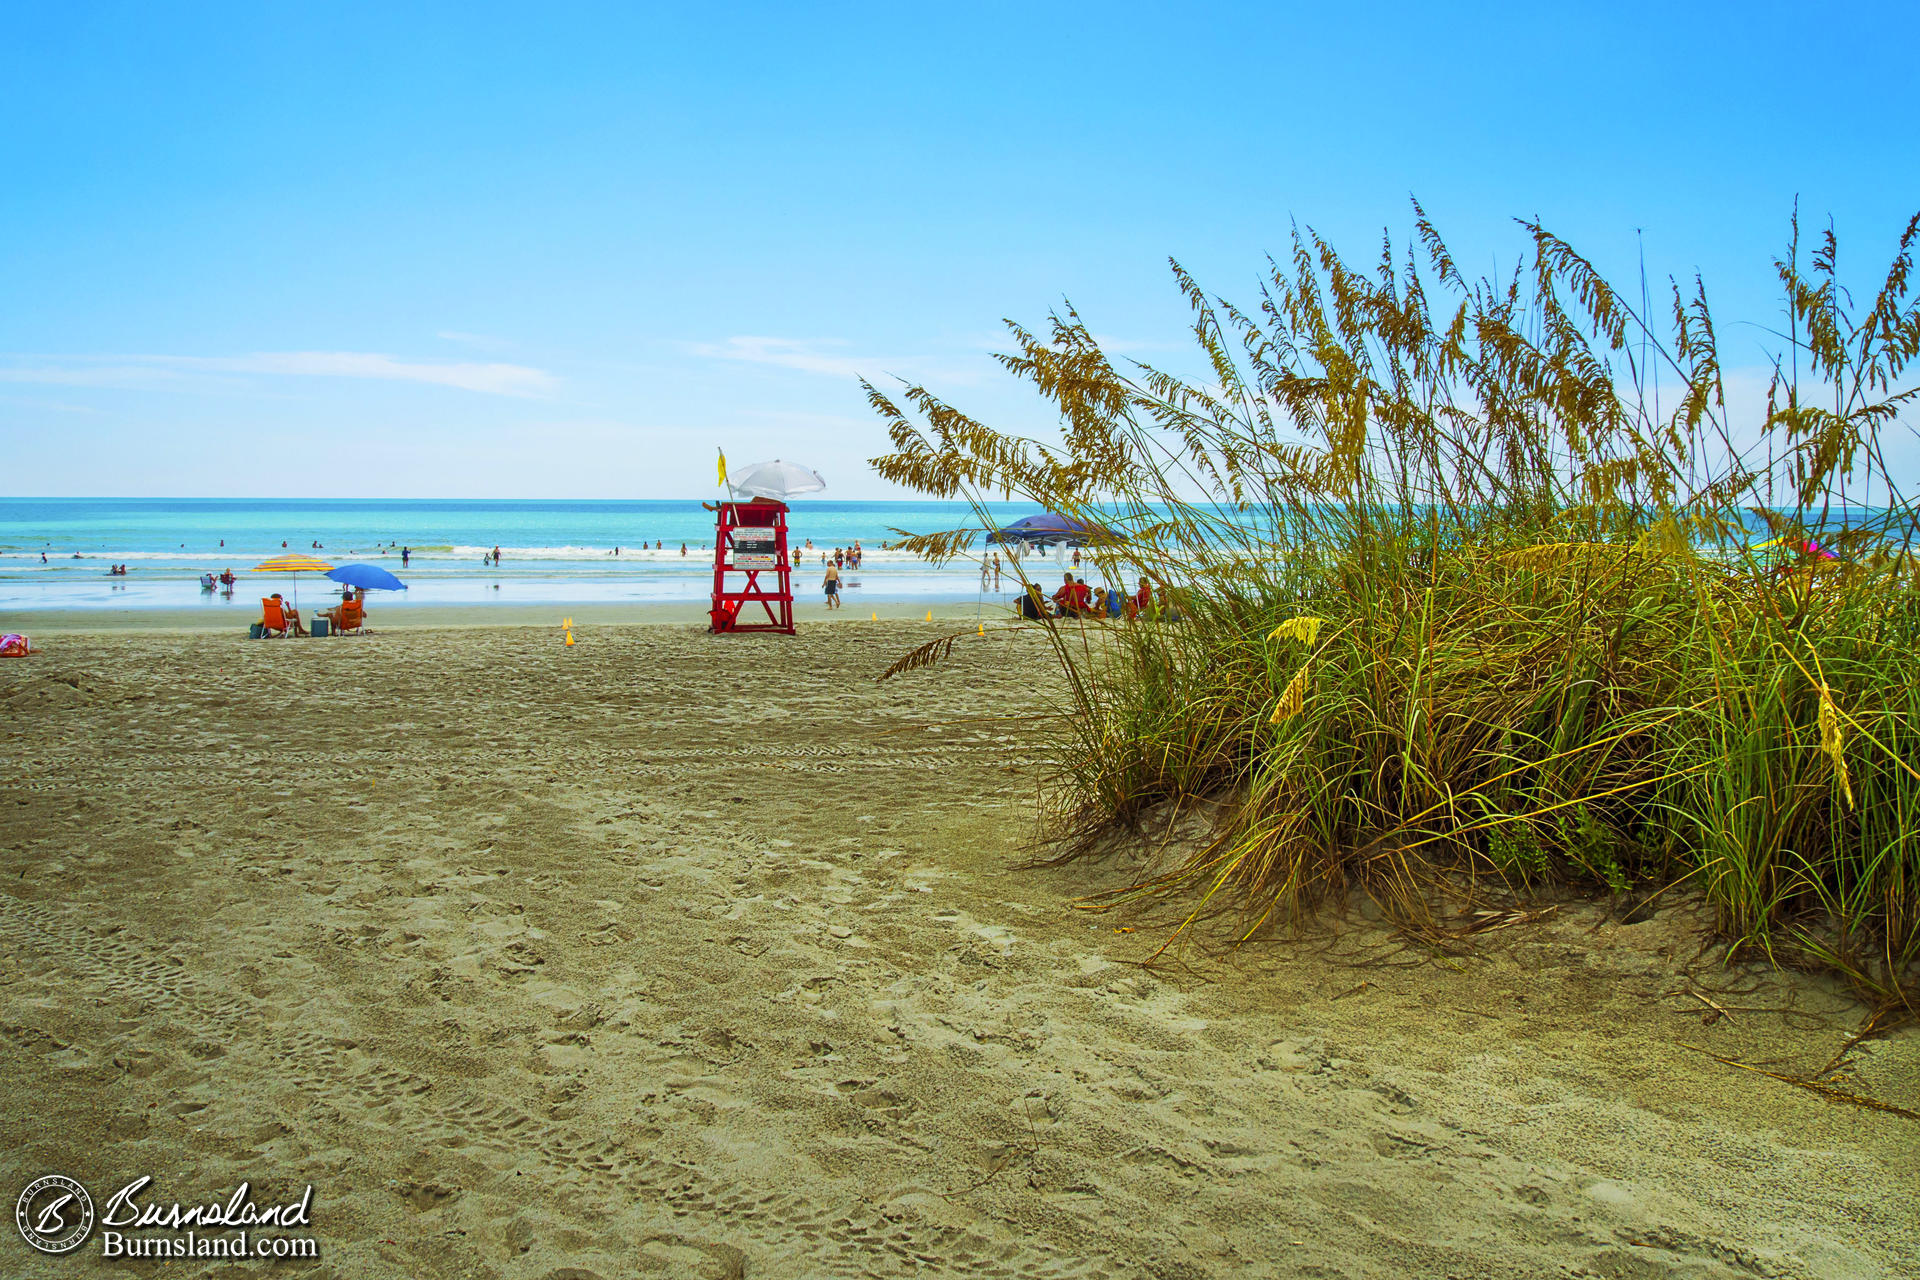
[868,205,1920,1002]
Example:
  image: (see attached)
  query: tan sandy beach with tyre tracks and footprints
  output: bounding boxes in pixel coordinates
[0,610,1920,1280]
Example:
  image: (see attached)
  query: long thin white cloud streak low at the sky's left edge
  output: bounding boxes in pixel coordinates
[0,351,557,395]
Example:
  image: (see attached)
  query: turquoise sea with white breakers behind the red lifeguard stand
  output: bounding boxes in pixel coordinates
[0,497,1067,612]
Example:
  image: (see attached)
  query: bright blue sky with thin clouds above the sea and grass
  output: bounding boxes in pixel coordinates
[0,4,1920,497]
